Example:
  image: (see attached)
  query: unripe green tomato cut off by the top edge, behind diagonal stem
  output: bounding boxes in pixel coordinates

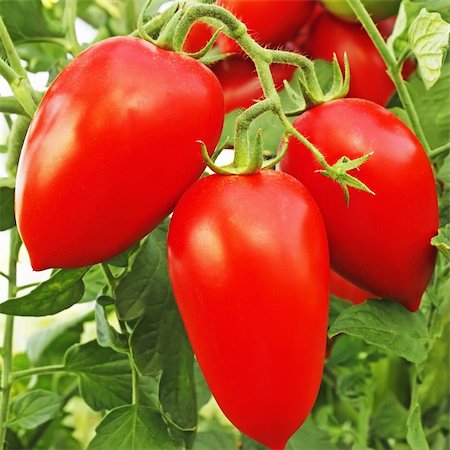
[322,0,400,22]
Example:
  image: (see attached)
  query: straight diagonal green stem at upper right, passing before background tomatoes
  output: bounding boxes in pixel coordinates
[347,0,430,153]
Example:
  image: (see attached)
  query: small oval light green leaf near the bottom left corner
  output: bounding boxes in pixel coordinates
[9,389,62,430]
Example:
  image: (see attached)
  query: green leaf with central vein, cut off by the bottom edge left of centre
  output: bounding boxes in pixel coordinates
[88,405,175,450]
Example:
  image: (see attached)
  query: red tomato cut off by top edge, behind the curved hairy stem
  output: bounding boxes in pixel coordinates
[217,0,315,53]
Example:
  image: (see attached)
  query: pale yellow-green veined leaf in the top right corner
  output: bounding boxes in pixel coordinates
[408,9,450,89]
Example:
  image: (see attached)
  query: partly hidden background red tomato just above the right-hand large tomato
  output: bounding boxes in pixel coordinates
[306,13,411,105]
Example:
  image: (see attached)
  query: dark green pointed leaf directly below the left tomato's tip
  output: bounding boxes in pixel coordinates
[0,268,88,317]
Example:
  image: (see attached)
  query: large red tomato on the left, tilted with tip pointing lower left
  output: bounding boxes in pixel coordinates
[16,37,224,270]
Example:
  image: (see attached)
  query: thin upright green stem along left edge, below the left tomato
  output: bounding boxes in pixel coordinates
[0,228,19,448]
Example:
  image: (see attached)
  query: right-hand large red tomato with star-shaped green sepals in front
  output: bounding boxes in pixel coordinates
[281,99,438,311]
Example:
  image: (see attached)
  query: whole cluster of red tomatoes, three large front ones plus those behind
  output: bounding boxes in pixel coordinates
[16,0,438,449]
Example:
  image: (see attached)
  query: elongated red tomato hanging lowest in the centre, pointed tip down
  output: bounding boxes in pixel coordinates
[168,171,329,450]
